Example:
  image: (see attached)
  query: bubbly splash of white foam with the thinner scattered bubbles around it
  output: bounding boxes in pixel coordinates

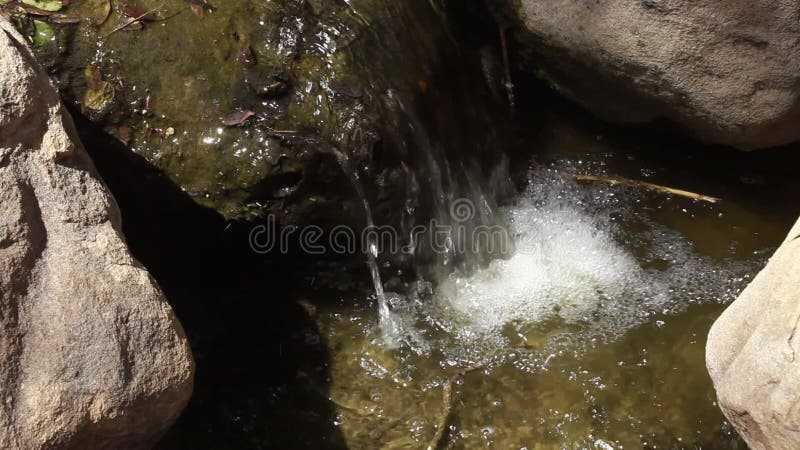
[425,170,752,358]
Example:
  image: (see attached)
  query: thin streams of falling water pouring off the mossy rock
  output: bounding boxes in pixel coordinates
[333,90,513,353]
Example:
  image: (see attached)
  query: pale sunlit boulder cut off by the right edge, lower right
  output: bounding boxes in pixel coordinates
[706,217,800,450]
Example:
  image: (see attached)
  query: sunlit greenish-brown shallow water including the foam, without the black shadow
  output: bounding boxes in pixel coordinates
[306,156,766,448]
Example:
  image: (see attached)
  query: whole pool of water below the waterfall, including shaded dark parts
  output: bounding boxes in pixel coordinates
[147,105,798,449]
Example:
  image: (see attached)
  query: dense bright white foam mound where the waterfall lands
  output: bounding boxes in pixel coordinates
[439,188,643,330]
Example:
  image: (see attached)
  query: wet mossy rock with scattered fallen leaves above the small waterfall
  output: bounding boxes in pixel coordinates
[29,0,482,222]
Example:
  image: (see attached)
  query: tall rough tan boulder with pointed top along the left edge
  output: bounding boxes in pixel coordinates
[0,16,194,449]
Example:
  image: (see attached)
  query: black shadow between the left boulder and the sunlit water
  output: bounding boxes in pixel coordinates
[72,111,346,449]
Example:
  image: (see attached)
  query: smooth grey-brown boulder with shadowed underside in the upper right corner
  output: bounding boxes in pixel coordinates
[496,0,800,149]
